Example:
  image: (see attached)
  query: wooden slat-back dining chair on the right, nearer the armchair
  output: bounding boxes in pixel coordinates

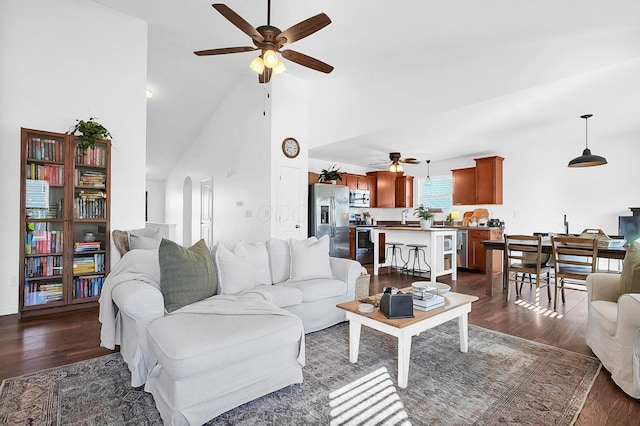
[551,236,598,311]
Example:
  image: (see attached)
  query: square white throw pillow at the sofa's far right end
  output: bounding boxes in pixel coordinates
[289,235,334,282]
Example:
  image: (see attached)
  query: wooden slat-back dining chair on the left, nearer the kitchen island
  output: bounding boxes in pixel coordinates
[504,234,551,305]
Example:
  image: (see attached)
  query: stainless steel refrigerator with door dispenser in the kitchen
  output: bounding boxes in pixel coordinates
[309,183,349,258]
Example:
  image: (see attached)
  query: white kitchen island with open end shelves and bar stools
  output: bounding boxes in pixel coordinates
[371,226,458,281]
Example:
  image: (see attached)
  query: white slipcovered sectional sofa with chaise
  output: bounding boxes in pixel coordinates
[100,238,362,424]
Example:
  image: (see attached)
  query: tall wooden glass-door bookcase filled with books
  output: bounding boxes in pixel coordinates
[19,128,111,317]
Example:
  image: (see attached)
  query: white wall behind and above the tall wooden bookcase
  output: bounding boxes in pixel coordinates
[0,0,147,315]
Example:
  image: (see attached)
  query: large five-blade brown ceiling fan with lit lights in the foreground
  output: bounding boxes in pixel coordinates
[193,0,333,83]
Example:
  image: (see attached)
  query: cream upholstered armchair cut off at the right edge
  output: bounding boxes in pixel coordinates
[586,273,640,398]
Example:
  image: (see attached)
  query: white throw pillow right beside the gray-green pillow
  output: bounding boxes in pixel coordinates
[214,244,254,294]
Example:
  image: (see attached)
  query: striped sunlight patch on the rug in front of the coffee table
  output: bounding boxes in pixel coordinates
[329,367,411,426]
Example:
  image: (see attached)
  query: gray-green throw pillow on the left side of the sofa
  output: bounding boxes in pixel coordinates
[158,238,217,312]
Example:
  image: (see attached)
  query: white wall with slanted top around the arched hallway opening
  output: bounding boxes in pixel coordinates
[166,73,272,245]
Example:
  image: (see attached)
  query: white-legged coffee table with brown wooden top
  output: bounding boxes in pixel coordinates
[337,288,478,388]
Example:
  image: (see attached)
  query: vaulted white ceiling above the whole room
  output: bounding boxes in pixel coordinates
[94,0,640,179]
